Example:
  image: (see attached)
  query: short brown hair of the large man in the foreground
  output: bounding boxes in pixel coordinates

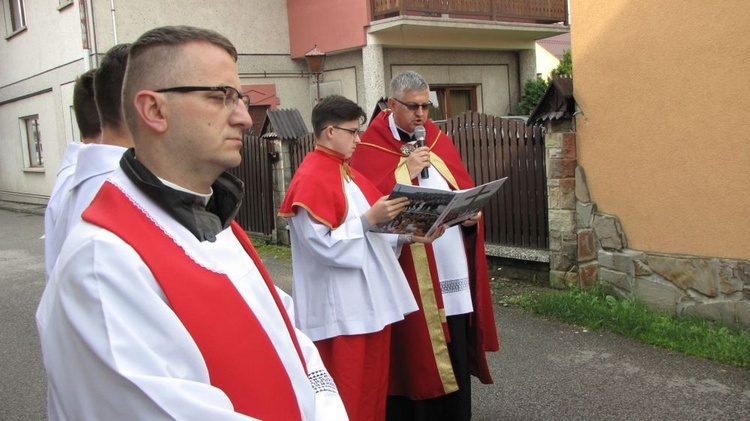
[122,25,237,134]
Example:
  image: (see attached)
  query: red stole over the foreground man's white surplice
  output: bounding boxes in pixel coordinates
[82,182,307,420]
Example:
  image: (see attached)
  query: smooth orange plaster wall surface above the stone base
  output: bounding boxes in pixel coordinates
[570,0,750,259]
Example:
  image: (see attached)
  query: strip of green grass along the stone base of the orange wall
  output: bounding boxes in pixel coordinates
[504,288,750,369]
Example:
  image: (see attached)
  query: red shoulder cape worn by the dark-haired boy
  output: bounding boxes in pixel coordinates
[279,145,383,230]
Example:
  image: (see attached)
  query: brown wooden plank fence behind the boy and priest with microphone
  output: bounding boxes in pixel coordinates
[282,112,549,250]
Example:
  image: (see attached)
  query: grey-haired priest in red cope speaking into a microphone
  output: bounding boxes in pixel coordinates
[351,71,498,421]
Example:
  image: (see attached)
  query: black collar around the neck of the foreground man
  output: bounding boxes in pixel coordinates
[120,148,244,242]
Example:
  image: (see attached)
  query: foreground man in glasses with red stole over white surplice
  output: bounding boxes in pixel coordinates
[36,26,347,420]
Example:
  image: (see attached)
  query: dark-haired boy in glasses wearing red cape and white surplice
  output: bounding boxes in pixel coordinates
[279,95,442,420]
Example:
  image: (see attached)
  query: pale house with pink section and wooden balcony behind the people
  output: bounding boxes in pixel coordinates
[0,0,568,203]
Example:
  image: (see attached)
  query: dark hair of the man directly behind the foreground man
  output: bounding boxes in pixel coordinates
[94,44,130,127]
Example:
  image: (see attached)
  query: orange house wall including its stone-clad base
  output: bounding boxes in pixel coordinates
[568,0,750,326]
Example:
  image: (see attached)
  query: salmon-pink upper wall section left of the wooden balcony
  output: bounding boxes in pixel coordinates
[287,0,370,58]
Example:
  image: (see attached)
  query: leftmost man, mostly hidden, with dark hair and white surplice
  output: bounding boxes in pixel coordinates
[44,69,102,279]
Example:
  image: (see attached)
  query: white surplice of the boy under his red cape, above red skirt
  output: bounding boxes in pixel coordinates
[289,181,417,341]
